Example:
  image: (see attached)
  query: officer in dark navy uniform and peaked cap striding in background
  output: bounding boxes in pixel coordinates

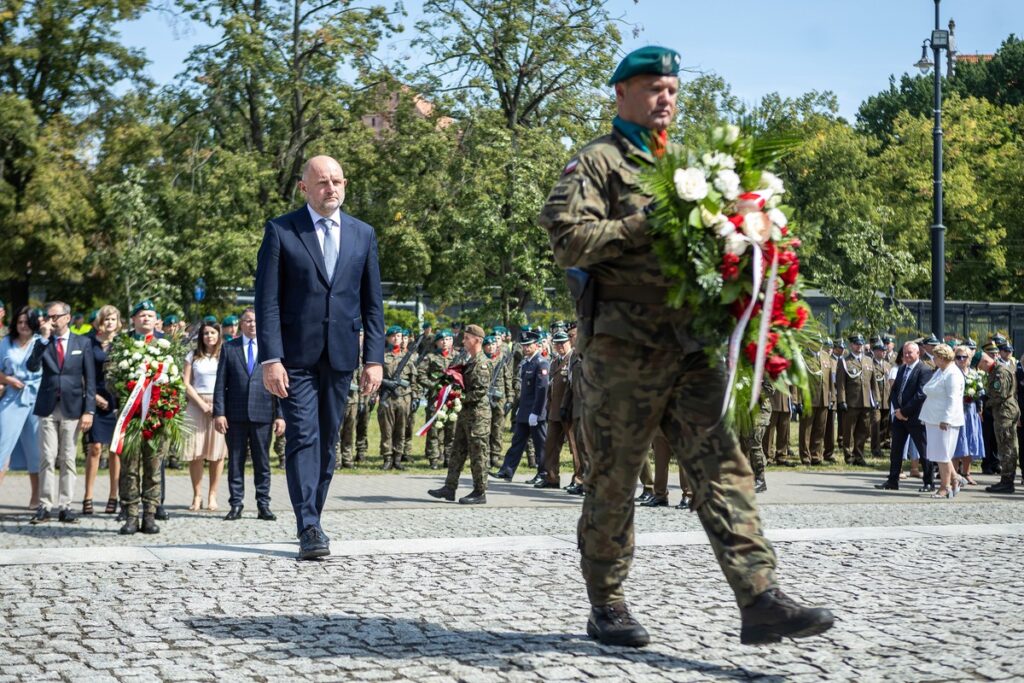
[490,332,551,484]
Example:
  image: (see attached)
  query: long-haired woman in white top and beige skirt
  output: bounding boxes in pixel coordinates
[182,323,227,512]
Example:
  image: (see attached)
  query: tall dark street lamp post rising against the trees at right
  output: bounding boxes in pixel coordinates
[914,0,955,339]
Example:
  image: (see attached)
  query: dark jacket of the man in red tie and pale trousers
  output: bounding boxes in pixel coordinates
[26,334,96,420]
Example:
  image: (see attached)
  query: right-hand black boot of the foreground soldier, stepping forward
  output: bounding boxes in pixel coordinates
[739,588,835,645]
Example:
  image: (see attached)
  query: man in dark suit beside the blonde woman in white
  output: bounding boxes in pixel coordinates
[874,342,935,490]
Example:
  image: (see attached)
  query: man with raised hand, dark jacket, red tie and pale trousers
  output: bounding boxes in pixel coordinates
[26,301,96,524]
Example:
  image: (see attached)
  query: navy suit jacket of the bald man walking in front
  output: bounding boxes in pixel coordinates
[256,205,384,372]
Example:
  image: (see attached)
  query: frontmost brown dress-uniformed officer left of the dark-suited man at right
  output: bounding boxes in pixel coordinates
[836,335,879,466]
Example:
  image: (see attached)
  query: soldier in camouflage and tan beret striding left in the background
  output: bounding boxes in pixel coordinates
[427,325,496,505]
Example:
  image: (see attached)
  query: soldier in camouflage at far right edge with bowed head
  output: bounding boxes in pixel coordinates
[978,341,1021,494]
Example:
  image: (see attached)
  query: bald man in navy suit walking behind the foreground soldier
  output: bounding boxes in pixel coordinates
[256,157,384,559]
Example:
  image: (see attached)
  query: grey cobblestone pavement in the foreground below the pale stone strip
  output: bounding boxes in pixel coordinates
[0,537,1024,682]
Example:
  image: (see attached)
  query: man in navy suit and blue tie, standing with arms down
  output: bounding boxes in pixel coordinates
[213,308,285,521]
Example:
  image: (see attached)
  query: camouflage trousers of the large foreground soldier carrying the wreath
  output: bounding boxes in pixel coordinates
[579,335,775,606]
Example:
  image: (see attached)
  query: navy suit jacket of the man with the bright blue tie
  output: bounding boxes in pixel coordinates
[213,335,278,424]
